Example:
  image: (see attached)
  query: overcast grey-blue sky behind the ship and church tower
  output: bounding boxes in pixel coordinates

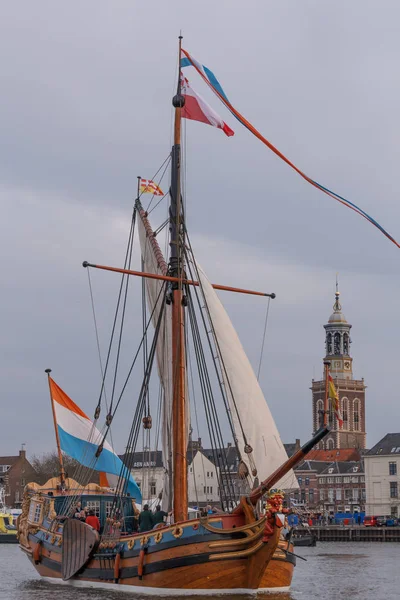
[0,0,400,455]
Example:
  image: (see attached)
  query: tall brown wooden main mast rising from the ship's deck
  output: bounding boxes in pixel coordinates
[169,36,188,522]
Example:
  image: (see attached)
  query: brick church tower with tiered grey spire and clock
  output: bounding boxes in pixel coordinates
[311,283,366,450]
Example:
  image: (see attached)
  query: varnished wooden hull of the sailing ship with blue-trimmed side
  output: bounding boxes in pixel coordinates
[21,516,293,594]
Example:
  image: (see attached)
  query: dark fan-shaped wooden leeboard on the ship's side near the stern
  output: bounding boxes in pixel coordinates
[61,519,99,581]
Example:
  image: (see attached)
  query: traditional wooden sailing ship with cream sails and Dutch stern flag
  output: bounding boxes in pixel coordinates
[18,39,328,595]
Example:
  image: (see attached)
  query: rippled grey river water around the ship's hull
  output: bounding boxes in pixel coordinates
[0,542,400,600]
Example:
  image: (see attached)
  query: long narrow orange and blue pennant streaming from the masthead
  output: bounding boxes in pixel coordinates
[181,48,400,248]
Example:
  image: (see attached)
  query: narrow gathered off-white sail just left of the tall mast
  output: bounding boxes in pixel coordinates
[138,211,173,510]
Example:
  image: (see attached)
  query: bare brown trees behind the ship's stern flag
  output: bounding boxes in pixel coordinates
[30,452,99,485]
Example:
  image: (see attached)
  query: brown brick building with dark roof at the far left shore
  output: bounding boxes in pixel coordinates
[0,450,38,508]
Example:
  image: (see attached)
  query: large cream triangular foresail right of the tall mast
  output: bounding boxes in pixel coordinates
[197,263,298,489]
